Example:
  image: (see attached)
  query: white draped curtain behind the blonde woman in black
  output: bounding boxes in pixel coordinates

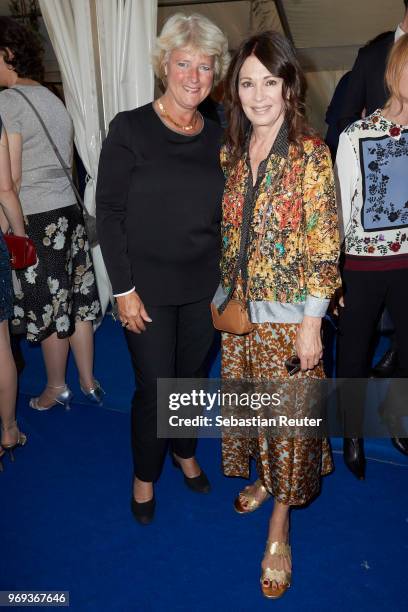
[39,0,157,312]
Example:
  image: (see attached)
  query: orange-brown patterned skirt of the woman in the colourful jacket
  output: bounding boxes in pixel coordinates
[221,323,333,506]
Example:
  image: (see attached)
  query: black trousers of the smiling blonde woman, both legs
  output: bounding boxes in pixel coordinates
[125,296,214,482]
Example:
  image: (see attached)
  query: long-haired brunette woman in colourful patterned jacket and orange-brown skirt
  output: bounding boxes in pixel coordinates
[214,32,339,598]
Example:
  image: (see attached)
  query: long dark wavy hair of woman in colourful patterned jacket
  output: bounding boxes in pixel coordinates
[224,30,314,165]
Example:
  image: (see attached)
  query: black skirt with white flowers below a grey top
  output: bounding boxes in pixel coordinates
[11,205,101,342]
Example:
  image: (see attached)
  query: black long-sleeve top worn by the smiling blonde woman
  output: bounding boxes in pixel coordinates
[96,104,224,305]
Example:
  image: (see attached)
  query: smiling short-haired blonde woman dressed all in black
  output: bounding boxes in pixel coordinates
[96,13,229,524]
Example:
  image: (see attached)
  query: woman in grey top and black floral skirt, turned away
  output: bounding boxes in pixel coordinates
[0,17,102,410]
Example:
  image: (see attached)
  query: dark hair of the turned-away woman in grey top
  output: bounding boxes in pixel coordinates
[0,17,44,81]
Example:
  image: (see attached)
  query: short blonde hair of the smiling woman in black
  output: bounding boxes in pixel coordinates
[152,13,230,85]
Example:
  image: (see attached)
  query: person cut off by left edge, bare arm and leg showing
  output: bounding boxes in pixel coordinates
[0,117,27,470]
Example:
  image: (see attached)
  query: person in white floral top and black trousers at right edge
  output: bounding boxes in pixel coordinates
[336,34,408,479]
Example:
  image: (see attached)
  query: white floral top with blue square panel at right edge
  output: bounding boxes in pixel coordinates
[336,109,408,268]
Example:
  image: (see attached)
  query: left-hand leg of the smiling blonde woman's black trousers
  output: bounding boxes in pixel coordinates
[125,306,178,482]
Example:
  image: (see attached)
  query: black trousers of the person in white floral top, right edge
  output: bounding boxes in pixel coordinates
[337,269,408,438]
